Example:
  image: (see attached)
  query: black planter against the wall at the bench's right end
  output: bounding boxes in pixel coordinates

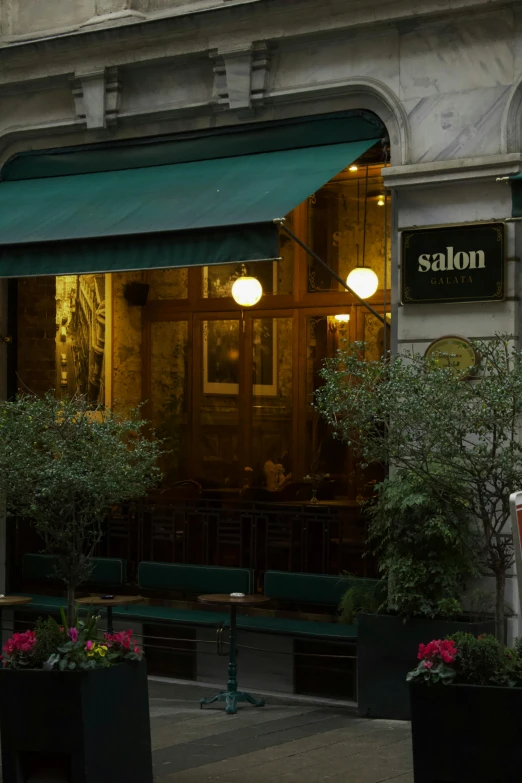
[357,614,494,724]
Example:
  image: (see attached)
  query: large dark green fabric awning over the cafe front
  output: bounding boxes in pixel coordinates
[0,136,376,277]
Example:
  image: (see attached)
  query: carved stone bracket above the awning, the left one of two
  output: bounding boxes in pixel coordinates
[72,68,121,128]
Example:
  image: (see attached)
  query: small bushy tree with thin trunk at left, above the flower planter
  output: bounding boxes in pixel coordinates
[0,393,160,625]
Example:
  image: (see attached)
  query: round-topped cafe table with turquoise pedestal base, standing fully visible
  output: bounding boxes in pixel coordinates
[198,593,270,715]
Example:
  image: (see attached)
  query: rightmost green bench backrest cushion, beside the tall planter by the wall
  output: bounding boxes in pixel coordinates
[263,571,378,606]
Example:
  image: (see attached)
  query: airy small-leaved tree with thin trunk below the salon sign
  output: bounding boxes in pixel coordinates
[316,335,522,640]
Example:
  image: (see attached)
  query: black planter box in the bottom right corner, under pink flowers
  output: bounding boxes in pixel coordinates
[410,684,522,783]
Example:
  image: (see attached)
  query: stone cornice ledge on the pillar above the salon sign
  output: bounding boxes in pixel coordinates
[382,153,522,190]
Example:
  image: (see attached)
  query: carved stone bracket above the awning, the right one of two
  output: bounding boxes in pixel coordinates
[210,43,270,110]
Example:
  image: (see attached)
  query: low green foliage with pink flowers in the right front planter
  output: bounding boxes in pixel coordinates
[407,632,522,688]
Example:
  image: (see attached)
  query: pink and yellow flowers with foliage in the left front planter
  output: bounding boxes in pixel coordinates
[3,612,143,671]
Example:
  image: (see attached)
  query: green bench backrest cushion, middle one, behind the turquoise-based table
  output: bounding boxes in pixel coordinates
[138,563,253,595]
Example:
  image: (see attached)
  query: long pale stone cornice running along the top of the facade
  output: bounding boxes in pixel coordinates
[0,0,520,66]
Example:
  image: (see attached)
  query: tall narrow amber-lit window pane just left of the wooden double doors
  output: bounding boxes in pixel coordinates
[151,321,188,486]
